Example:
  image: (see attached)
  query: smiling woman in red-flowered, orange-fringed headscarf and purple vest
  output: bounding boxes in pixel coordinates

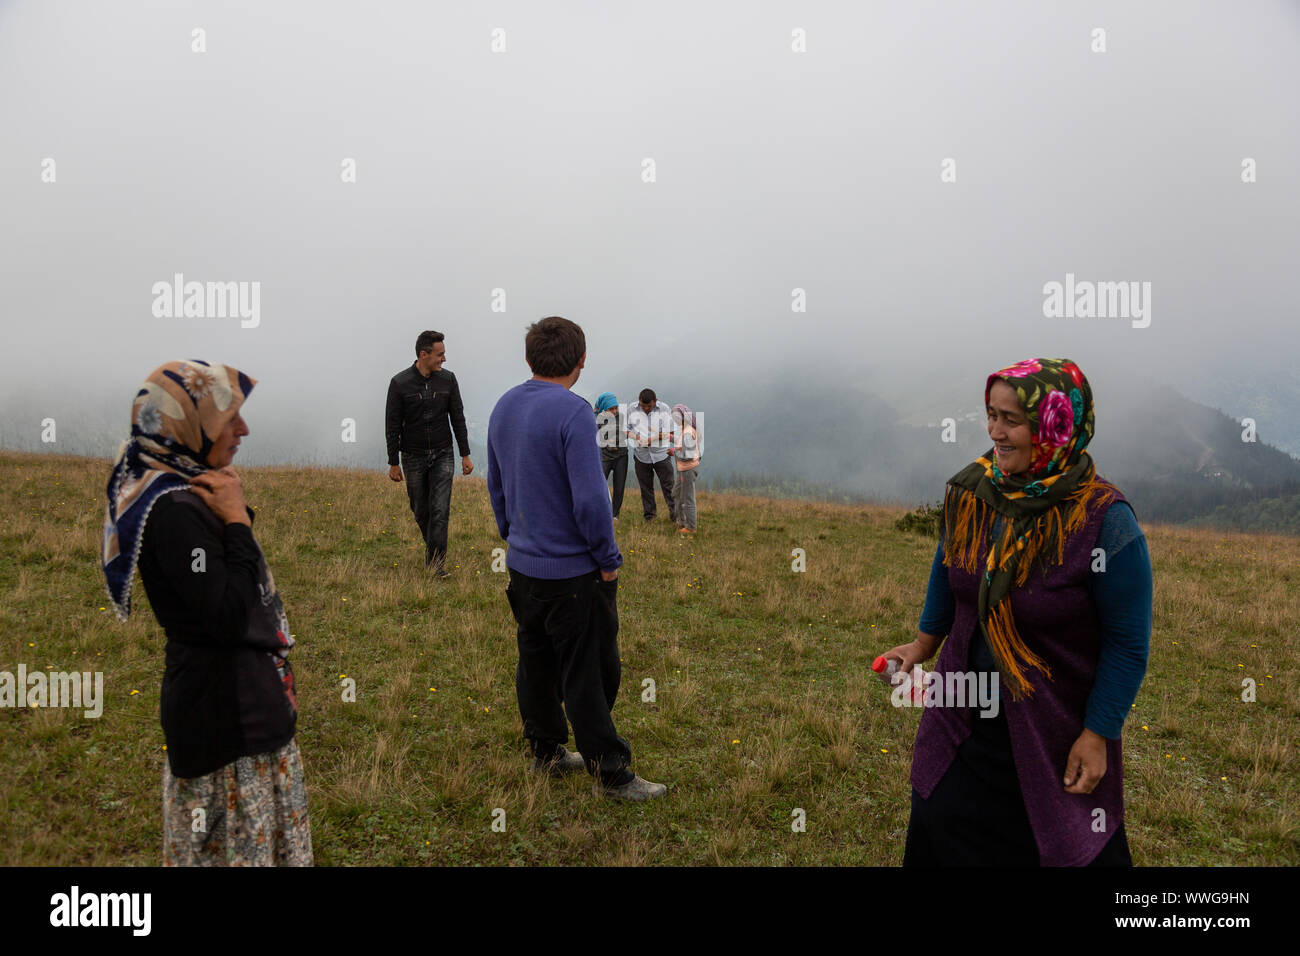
[887,359,1152,866]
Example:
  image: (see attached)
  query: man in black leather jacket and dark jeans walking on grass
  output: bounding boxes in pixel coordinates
[385,332,475,578]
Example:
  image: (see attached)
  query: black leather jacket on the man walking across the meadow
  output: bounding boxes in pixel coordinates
[384,362,469,466]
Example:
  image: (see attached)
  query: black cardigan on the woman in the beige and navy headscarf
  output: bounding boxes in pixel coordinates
[139,490,298,777]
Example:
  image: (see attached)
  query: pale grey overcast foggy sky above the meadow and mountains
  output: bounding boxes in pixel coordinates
[0,0,1300,467]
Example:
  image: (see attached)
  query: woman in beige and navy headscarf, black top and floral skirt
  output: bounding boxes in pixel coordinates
[103,360,312,866]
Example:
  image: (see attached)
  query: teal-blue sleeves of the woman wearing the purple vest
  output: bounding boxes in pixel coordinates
[919,502,1153,739]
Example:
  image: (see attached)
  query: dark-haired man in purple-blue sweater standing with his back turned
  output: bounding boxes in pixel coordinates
[488,316,667,800]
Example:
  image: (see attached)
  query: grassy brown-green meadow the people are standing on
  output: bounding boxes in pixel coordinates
[0,453,1300,866]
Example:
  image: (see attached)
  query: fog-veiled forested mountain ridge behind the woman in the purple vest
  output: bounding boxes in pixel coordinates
[598,377,1300,533]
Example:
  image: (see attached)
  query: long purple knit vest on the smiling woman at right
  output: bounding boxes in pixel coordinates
[911,489,1125,866]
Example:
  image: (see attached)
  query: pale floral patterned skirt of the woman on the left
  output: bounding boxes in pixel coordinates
[163,740,312,866]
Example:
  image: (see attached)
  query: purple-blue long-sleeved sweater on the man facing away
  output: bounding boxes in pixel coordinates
[488,380,623,580]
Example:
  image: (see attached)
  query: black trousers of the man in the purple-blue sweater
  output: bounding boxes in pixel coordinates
[506,568,633,787]
